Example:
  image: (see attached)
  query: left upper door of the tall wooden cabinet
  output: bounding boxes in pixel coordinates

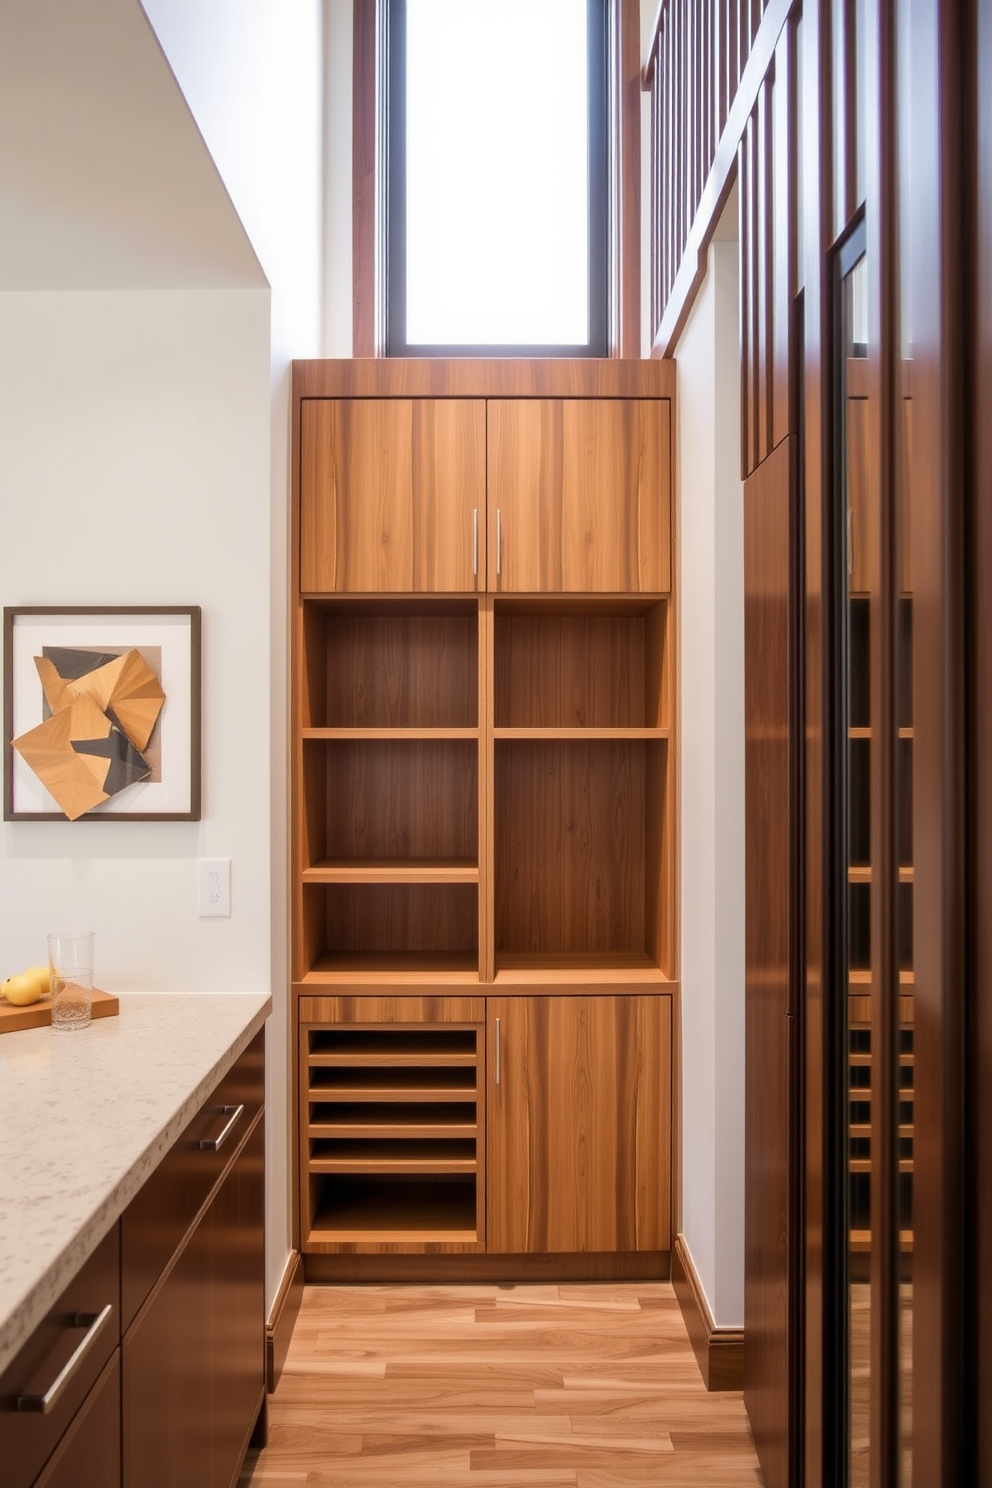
[300,399,486,594]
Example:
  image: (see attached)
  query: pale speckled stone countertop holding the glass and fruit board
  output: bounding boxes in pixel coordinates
[0,992,272,1370]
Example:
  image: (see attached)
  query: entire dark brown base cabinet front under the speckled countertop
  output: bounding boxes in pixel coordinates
[0,1033,265,1488]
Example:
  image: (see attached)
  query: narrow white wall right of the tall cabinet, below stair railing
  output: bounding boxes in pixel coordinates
[675,241,744,1327]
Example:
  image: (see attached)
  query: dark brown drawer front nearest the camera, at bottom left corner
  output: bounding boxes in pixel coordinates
[0,1225,120,1488]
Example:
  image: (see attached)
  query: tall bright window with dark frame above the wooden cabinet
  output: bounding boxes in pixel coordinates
[385,0,608,356]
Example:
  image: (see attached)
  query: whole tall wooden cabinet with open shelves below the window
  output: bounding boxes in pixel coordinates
[292,359,678,1274]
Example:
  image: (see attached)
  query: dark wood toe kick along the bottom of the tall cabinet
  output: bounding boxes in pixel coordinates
[303,1250,671,1284]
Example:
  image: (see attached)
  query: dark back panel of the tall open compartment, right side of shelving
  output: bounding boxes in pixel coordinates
[494,740,648,967]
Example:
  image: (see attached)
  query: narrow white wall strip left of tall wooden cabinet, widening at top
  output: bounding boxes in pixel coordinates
[133,0,323,1302]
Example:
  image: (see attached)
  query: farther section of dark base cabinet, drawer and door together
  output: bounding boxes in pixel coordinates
[122,1034,265,1488]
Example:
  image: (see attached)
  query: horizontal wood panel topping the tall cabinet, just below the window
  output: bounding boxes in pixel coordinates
[293,357,675,397]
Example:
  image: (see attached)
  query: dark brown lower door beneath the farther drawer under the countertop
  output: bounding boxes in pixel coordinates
[122,1117,265,1488]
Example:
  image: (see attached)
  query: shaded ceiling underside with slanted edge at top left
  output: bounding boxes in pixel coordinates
[0,0,266,290]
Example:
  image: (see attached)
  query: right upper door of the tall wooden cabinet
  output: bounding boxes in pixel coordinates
[488,399,671,594]
